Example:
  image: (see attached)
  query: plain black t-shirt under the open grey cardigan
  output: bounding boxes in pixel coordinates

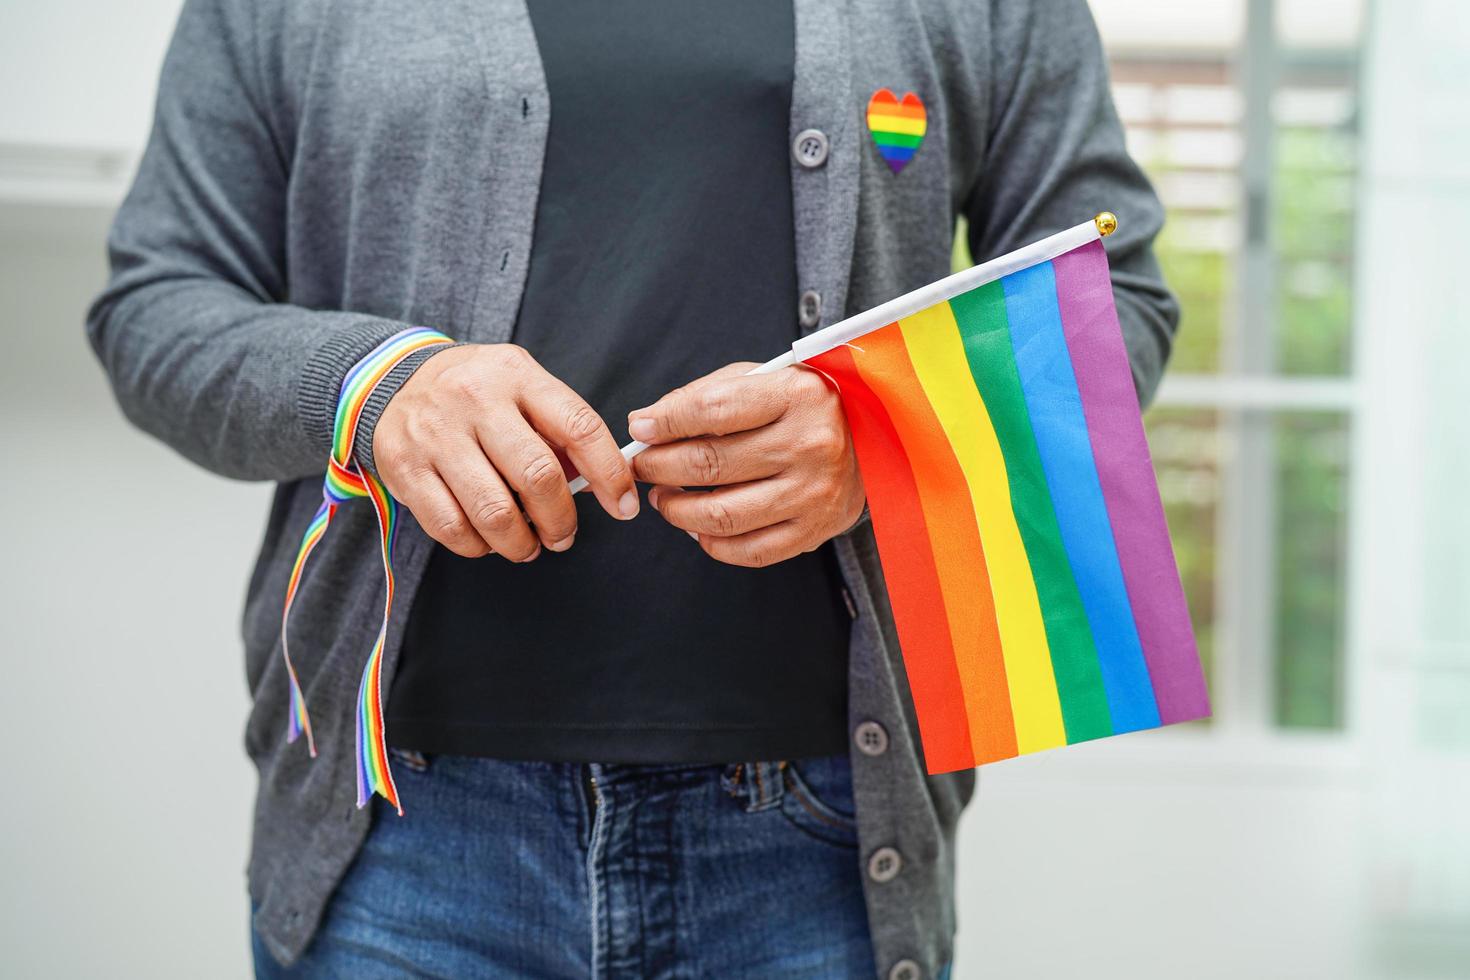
[388,0,850,763]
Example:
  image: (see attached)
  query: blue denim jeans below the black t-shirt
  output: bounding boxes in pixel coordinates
[254,752,875,980]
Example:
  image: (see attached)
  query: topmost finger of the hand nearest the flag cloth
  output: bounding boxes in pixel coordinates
[628,370,797,444]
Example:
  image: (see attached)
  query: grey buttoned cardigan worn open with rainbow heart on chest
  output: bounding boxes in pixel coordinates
[87,0,1177,980]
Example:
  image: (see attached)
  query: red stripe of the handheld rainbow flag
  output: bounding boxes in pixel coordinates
[807,347,981,773]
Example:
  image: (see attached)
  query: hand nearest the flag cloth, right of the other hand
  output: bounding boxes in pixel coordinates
[628,363,866,569]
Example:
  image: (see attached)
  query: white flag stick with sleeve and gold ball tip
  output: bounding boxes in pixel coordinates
[567,212,1117,494]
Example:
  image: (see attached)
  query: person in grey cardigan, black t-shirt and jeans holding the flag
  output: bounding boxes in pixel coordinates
[87,0,1177,980]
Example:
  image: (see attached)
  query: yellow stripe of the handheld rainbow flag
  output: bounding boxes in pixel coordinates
[893,303,1067,754]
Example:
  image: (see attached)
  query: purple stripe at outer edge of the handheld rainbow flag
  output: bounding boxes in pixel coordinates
[1051,241,1210,724]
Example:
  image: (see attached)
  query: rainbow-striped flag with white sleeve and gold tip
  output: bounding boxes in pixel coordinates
[799,215,1210,773]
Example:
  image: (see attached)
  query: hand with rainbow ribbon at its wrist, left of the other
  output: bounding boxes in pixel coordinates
[372,344,638,561]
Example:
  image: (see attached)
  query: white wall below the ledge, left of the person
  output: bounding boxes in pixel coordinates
[0,206,268,977]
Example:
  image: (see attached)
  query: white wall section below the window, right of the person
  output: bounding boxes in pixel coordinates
[957,733,1376,980]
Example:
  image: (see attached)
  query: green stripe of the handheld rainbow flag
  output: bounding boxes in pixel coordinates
[950,282,1113,742]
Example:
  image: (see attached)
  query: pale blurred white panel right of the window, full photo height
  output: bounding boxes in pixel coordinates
[1354,0,1470,976]
